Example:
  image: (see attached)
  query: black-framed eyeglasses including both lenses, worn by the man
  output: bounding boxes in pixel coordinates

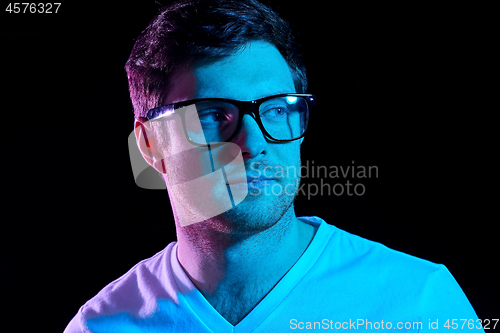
[146,94,316,147]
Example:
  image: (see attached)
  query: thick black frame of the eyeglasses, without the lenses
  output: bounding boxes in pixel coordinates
[146,93,316,147]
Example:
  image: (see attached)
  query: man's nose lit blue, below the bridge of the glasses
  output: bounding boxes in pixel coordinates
[232,114,267,160]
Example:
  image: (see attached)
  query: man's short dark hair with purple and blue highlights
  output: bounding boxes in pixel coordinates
[125,0,307,118]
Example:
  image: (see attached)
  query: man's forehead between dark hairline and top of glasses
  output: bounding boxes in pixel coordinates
[166,41,295,104]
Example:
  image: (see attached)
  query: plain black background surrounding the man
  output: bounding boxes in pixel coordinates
[0,1,500,332]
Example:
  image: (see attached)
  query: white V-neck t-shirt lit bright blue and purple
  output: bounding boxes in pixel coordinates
[65,217,484,333]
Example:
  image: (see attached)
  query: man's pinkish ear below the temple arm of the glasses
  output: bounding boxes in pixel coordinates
[134,117,165,173]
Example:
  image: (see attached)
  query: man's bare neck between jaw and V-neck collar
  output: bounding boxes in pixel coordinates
[177,205,315,322]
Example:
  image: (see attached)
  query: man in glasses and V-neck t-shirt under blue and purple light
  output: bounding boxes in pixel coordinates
[66,0,480,332]
